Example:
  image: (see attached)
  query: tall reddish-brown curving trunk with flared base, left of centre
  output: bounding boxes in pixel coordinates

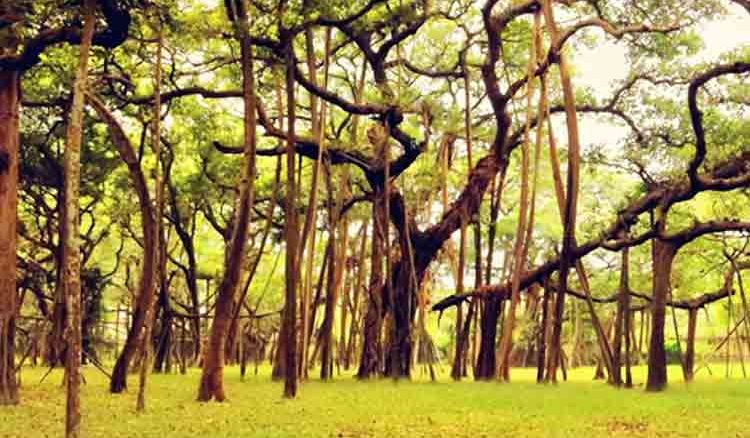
[198,0,256,402]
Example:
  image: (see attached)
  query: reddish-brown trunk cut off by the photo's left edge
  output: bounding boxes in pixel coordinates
[0,71,20,405]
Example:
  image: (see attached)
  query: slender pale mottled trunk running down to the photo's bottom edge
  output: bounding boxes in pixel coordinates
[63,0,96,432]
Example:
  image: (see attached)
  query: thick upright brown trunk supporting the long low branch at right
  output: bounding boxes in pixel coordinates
[646,239,678,391]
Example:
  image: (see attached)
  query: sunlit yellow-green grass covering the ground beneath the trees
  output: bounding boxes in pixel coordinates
[0,366,750,438]
